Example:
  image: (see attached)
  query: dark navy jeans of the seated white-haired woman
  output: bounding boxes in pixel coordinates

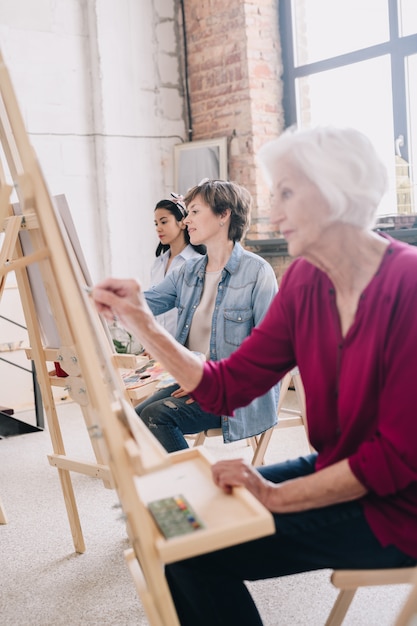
[165,454,416,626]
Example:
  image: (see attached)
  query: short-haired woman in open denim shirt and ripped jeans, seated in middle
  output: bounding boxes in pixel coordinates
[136,180,278,452]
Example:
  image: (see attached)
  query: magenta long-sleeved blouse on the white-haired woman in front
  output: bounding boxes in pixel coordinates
[193,238,417,558]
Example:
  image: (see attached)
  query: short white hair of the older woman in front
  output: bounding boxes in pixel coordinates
[258,126,388,229]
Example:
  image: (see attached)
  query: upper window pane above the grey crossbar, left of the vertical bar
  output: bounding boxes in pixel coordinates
[292,0,388,66]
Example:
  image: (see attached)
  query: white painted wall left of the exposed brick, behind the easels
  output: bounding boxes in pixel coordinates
[0,0,186,406]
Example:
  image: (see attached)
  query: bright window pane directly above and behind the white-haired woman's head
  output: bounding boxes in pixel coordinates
[296,56,397,215]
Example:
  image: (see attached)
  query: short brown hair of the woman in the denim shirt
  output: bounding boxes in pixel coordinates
[184,179,252,241]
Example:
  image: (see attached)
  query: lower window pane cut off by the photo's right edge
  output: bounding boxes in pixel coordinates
[406,54,417,213]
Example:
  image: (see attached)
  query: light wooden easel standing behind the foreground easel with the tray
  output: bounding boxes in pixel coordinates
[0,100,113,552]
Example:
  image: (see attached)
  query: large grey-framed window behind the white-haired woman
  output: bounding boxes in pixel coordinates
[279,0,417,217]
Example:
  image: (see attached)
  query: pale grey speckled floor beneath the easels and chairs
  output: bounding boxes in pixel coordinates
[0,403,408,626]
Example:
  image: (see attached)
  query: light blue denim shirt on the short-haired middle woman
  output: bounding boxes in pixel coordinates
[145,243,279,443]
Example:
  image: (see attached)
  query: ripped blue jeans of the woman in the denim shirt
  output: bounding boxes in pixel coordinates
[135,384,221,452]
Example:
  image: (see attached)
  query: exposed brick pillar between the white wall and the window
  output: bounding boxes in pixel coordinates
[184,0,283,239]
